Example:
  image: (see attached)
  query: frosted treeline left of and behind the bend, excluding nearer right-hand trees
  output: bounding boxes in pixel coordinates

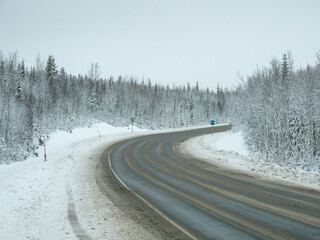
[0,52,234,163]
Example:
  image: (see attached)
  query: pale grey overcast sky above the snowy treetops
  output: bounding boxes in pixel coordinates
[0,0,320,89]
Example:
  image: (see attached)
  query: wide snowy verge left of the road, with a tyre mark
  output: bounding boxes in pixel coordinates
[0,123,152,240]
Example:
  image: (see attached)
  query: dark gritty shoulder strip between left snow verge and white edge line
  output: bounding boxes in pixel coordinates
[95,143,192,240]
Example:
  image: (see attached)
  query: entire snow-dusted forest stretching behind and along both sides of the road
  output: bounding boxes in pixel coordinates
[0,52,320,172]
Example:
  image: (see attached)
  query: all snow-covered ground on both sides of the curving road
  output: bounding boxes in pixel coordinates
[0,123,320,240]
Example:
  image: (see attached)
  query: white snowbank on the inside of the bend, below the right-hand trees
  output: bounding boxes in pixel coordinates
[182,129,320,190]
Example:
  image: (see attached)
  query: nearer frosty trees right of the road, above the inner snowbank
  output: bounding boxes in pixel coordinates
[237,53,320,171]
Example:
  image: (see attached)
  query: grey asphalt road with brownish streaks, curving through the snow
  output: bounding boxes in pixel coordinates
[104,125,320,240]
